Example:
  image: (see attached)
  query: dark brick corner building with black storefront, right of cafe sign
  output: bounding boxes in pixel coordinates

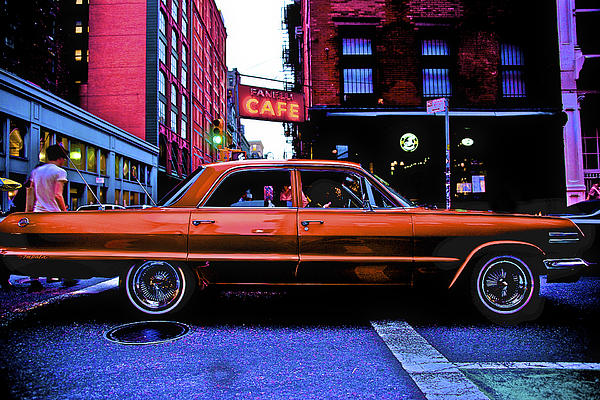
[286,0,565,211]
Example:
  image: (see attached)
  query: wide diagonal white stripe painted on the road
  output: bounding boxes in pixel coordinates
[371,321,489,400]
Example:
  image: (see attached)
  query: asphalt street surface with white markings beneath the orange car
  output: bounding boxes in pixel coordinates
[0,277,600,399]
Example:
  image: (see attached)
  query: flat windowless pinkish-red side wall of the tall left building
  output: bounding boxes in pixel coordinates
[82,0,146,139]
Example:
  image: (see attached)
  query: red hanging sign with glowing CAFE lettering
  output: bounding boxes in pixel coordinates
[238,85,304,122]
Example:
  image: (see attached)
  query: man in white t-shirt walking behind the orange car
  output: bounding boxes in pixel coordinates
[26,144,67,212]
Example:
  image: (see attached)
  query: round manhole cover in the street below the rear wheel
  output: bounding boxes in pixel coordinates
[104,321,190,344]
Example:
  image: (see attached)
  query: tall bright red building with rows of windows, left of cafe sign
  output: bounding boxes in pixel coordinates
[81,0,227,194]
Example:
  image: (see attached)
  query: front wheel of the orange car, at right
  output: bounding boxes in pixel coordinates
[471,255,543,324]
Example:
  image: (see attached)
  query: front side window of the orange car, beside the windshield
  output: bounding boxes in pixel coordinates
[300,170,366,208]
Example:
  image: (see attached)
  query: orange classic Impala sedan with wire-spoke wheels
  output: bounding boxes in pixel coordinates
[0,160,587,323]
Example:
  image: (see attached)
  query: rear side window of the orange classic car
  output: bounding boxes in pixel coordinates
[204,170,291,207]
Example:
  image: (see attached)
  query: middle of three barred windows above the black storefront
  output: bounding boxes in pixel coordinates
[421,39,452,97]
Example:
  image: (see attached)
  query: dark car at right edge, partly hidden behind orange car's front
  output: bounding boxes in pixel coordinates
[554,200,600,264]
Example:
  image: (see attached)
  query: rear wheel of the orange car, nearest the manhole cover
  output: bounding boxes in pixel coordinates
[123,261,196,315]
